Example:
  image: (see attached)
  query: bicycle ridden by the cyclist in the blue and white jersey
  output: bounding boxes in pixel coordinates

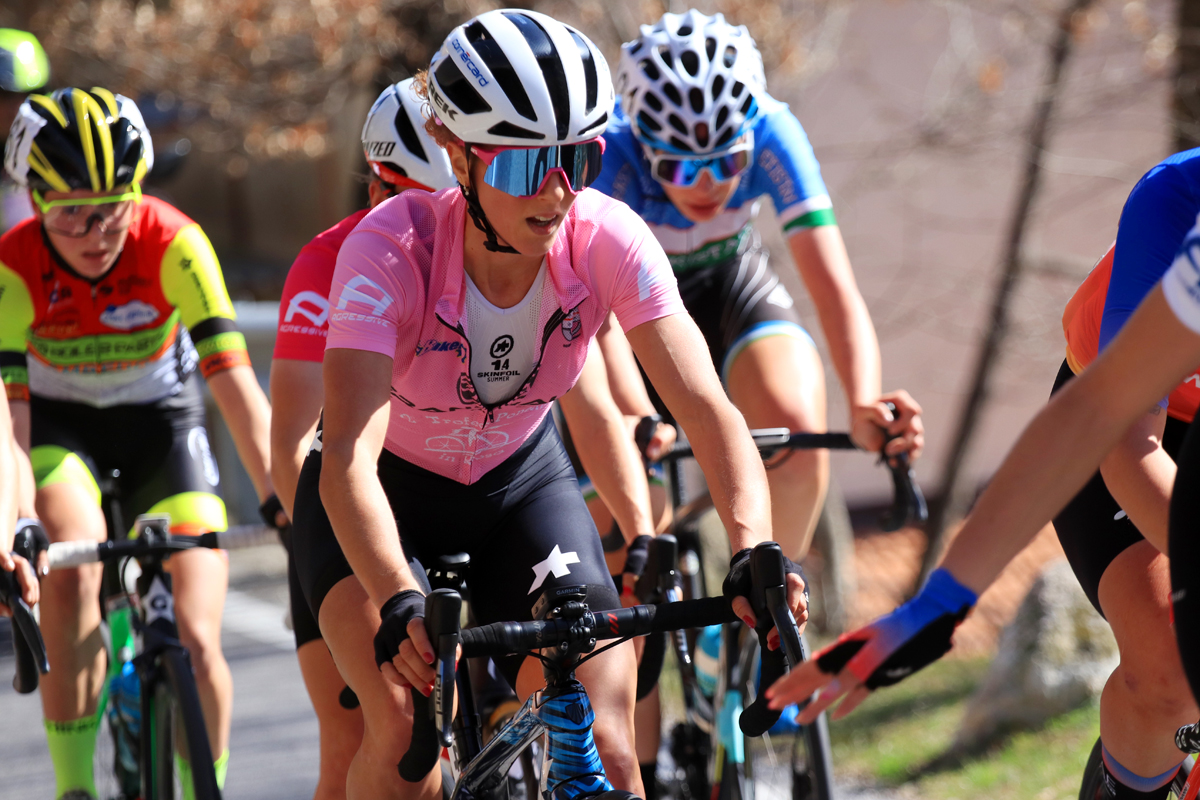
[638,428,928,800]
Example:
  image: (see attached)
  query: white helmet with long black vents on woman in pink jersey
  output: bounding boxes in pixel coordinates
[428,8,613,148]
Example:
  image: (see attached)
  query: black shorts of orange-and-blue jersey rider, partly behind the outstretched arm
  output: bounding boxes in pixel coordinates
[1050,361,1188,615]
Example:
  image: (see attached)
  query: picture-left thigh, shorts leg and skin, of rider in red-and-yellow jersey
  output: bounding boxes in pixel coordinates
[29,397,104,541]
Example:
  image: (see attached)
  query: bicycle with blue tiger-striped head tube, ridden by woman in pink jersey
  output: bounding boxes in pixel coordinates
[398,542,799,800]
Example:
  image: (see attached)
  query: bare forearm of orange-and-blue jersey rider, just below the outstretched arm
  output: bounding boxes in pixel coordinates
[1100,405,1176,554]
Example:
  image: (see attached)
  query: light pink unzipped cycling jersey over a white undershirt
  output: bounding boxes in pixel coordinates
[326,188,686,483]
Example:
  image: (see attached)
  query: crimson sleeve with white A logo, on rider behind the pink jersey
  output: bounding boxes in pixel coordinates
[274,209,370,363]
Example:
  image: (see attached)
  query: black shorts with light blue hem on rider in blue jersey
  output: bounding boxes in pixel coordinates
[676,234,816,381]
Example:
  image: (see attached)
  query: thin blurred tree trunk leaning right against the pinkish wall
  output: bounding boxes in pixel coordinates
[910,0,1099,594]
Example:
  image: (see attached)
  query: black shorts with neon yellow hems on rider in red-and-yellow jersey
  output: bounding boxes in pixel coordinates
[29,373,226,534]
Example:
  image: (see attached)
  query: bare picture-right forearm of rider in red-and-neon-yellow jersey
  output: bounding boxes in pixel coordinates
[209,366,274,500]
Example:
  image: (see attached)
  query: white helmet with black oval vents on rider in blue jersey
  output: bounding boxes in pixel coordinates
[617,8,767,154]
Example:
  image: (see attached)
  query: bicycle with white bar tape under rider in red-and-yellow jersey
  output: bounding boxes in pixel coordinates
[48,516,258,800]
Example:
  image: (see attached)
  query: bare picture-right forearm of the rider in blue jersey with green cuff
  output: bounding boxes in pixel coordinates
[788,225,882,408]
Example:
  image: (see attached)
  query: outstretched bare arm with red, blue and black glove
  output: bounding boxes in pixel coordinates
[768,287,1200,722]
